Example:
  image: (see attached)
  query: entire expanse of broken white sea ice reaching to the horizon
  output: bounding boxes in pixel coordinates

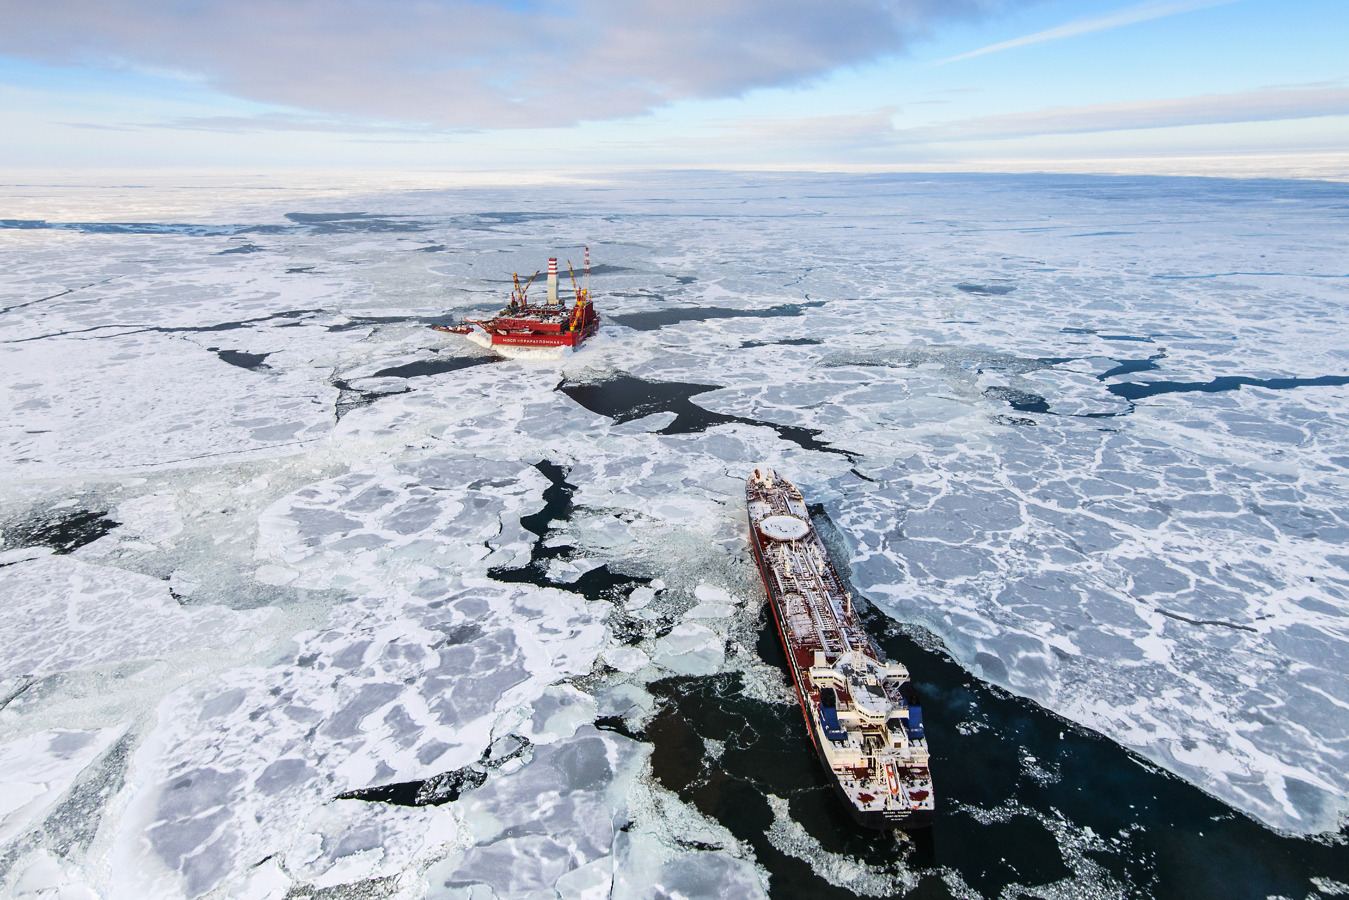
[0,177,1349,900]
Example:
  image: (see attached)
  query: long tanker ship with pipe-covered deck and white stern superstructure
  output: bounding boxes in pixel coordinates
[745,468,934,828]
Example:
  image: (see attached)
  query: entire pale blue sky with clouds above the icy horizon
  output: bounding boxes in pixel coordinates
[0,0,1349,178]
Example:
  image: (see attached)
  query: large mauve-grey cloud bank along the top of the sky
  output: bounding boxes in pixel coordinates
[0,0,1029,128]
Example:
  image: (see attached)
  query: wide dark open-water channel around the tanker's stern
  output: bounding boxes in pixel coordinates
[645,593,1349,900]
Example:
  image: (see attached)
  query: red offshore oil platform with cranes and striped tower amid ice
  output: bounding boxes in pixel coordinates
[437,247,599,349]
